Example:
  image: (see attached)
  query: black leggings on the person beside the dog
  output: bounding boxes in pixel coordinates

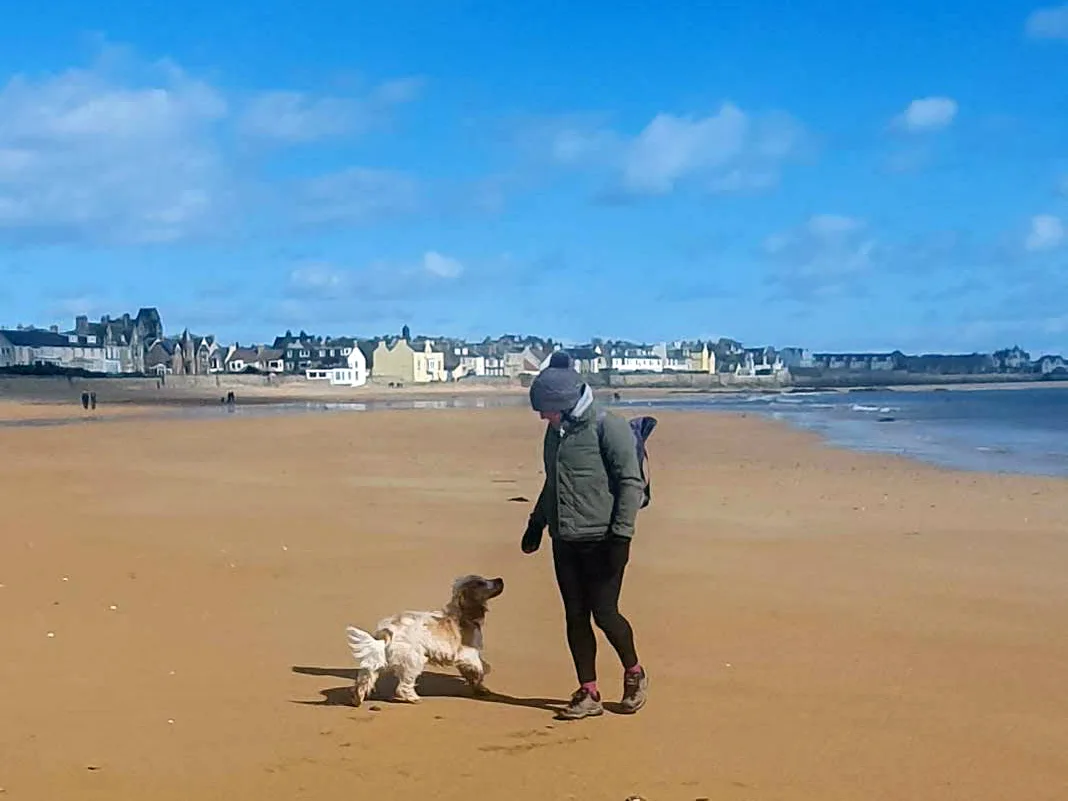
[552,537,638,684]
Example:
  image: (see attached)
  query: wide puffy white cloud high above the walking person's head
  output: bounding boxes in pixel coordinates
[538,103,803,195]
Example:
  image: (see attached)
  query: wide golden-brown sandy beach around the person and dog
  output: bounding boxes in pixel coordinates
[0,404,1068,801]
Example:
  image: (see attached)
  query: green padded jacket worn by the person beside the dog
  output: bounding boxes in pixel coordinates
[531,387,645,540]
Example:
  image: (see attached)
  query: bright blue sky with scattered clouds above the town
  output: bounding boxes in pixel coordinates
[0,0,1068,356]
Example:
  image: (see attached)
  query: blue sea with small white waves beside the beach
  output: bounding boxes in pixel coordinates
[621,383,1068,476]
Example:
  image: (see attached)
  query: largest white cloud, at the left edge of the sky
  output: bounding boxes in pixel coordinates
[0,55,227,244]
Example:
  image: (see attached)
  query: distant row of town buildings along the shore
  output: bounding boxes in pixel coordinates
[0,308,1068,387]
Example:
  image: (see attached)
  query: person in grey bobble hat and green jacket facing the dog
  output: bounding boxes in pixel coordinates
[521,351,648,720]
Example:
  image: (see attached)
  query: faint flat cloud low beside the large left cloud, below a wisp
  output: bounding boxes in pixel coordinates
[297,167,419,225]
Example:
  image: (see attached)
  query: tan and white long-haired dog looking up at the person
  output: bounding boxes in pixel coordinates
[345,576,504,706]
